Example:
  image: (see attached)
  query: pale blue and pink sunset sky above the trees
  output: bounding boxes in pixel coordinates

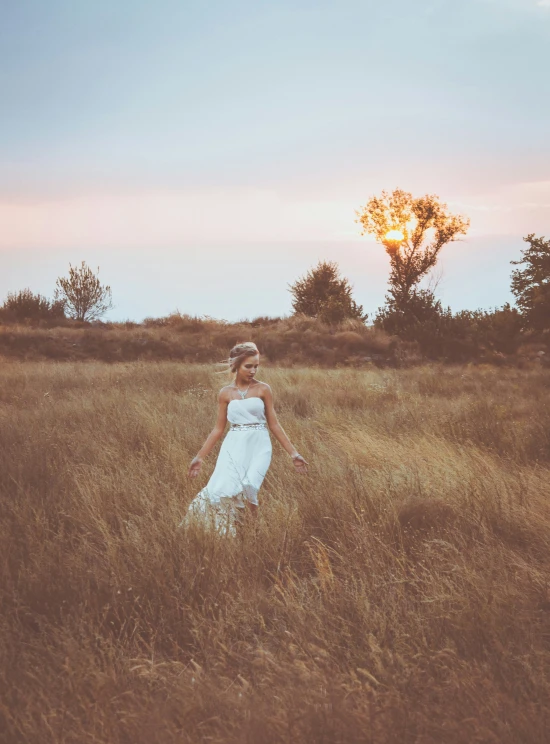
[0,0,550,320]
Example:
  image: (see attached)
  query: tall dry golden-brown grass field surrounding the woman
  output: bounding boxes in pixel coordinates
[0,362,550,744]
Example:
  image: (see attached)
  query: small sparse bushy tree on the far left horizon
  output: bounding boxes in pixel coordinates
[55,261,113,320]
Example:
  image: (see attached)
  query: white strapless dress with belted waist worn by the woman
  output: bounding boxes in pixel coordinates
[184,397,271,534]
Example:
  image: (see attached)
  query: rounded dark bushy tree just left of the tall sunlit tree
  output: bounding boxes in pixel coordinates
[289,261,367,323]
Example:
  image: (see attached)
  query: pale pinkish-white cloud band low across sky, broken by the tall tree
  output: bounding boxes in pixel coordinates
[0,181,550,251]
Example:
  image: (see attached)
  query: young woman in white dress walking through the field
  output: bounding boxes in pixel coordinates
[184,342,308,534]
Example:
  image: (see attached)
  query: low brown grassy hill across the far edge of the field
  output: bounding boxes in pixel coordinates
[0,311,550,367]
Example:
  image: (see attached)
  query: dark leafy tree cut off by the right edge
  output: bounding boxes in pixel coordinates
[510,233,550,330]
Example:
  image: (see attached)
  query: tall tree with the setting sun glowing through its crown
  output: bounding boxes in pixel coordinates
[356,189,470,312]
